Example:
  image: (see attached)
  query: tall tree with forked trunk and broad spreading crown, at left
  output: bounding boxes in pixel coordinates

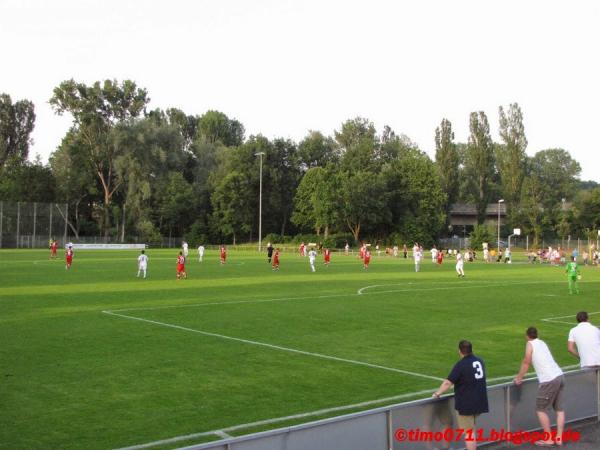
[50,79,149,236]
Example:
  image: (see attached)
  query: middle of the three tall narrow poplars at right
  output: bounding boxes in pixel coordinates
[465,111,494,224]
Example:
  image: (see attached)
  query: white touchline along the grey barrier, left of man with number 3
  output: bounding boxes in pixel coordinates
[117,388,435,450]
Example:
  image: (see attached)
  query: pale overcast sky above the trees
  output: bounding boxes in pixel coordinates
[0,0,600,181]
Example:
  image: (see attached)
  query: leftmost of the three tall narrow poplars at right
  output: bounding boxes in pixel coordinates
[435,119,460,212]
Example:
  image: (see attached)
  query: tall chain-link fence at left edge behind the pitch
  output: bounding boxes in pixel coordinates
[0,201,69,248]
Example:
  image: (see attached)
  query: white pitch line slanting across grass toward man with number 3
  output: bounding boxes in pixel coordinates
[102,311,444,381]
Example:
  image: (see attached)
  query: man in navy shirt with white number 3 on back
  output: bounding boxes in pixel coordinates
[433,340,489,450]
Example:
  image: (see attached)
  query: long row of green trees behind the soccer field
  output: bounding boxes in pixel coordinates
[0,80,600,245]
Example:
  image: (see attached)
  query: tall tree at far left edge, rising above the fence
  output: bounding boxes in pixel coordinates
[0,94,35,169]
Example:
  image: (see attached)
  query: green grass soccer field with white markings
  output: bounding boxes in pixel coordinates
[0,250,600,449]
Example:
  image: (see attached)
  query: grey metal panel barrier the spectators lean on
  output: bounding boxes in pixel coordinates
[182,370,600,450]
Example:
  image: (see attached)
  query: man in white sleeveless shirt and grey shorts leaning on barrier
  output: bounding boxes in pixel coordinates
[515,327,565,446]
